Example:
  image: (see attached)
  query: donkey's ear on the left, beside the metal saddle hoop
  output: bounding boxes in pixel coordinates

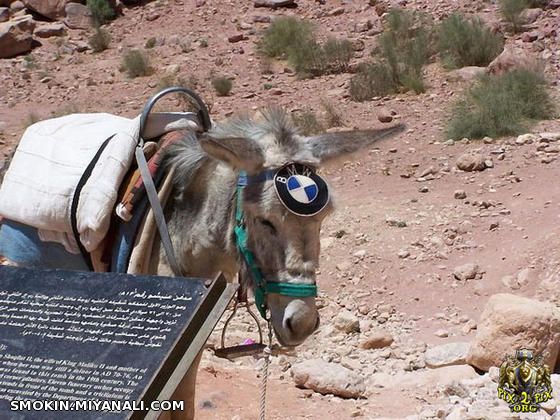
[199,133,264,172]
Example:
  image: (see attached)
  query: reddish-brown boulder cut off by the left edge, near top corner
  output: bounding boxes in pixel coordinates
[0,15,35,58]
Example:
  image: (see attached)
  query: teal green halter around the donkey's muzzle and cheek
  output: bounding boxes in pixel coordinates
[234,171,317,319]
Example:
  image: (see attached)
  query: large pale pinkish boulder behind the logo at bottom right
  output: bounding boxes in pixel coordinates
[467,293,560,371]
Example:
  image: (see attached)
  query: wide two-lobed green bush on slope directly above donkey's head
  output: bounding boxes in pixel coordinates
[258,17,354,77]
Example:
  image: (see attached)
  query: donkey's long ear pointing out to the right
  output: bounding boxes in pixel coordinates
[304,124,405,162]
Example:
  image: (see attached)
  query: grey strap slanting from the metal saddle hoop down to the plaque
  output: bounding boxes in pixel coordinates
[134,141,181,277]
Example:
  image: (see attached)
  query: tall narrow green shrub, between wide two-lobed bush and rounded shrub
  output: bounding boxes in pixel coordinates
[379,9,430,93]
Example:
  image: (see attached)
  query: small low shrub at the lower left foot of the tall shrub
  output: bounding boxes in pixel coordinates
[350,62,397,102]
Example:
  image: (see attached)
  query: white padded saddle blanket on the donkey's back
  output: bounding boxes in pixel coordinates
[0,113,199,254]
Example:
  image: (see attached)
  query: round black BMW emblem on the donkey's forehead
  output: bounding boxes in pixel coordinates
[274,163,329,216]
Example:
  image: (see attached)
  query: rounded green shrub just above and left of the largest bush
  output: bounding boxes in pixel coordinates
[438,14,504,68]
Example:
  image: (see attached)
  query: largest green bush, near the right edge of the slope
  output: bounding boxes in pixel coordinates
[448,70,554,139]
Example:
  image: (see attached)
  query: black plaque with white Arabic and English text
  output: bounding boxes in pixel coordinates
[0,266,234,420]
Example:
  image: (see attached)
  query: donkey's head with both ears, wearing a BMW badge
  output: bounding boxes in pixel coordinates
[201,108,402,346]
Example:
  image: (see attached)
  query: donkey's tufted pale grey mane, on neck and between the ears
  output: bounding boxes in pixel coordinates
[163,107,297,192]
